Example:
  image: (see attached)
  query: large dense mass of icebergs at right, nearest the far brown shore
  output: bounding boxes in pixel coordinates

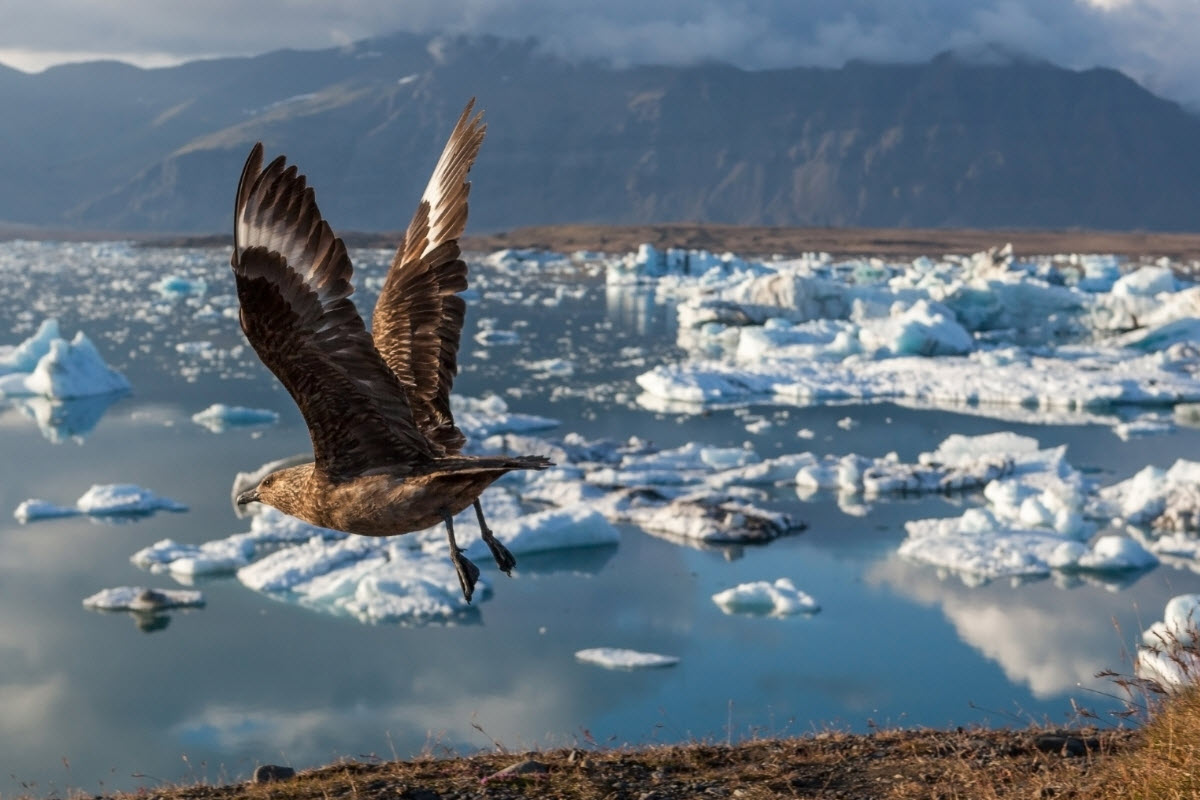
[624,246,1200,435]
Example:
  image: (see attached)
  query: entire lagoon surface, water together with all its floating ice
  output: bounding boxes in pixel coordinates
[0,241,1200,792]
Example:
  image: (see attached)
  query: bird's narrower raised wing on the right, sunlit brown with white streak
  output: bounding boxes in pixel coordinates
[372,100,487,455]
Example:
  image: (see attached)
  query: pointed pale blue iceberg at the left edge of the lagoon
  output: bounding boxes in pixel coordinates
[0,319,130,399]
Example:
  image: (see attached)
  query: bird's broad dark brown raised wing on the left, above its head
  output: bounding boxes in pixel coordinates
[233,144,433,479]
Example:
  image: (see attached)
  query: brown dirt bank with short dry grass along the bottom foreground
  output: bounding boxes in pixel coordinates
[100,729,1135,800]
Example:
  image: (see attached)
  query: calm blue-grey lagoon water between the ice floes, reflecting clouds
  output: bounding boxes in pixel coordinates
[0,242,1200,794]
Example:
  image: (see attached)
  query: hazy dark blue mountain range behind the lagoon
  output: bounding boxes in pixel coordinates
[0,34,1200,233]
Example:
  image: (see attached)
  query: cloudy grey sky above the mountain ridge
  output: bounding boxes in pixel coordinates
[0,0,1200,109]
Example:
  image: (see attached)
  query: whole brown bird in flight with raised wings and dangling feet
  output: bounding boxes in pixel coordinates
[233,101,550,602]
